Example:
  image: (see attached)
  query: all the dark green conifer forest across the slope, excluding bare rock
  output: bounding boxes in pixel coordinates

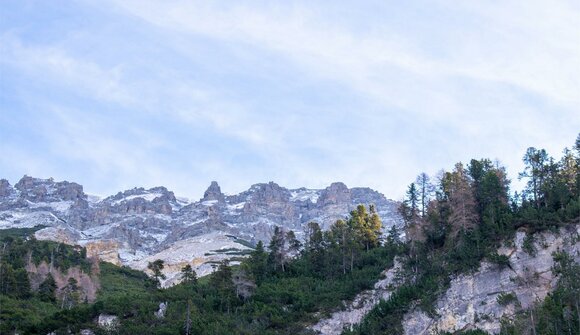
[0,135,580,335]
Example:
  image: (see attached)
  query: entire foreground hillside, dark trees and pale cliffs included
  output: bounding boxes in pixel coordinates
[0,136,580,335]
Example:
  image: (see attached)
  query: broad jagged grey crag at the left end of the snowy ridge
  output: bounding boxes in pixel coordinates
[14,175,87,202]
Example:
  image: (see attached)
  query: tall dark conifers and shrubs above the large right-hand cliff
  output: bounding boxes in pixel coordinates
[344,135,580,334]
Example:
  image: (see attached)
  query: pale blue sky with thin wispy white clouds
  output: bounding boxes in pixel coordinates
[0,0,580,199]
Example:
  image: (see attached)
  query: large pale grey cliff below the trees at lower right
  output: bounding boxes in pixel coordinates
[403,225,580,335]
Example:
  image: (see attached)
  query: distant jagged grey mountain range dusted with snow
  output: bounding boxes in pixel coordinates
[0,176,402,281]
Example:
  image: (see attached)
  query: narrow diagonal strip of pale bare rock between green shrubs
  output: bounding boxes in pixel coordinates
[310,260,401,335]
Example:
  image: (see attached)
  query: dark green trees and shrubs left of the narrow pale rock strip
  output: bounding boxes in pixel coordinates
[0,206,405,334]
